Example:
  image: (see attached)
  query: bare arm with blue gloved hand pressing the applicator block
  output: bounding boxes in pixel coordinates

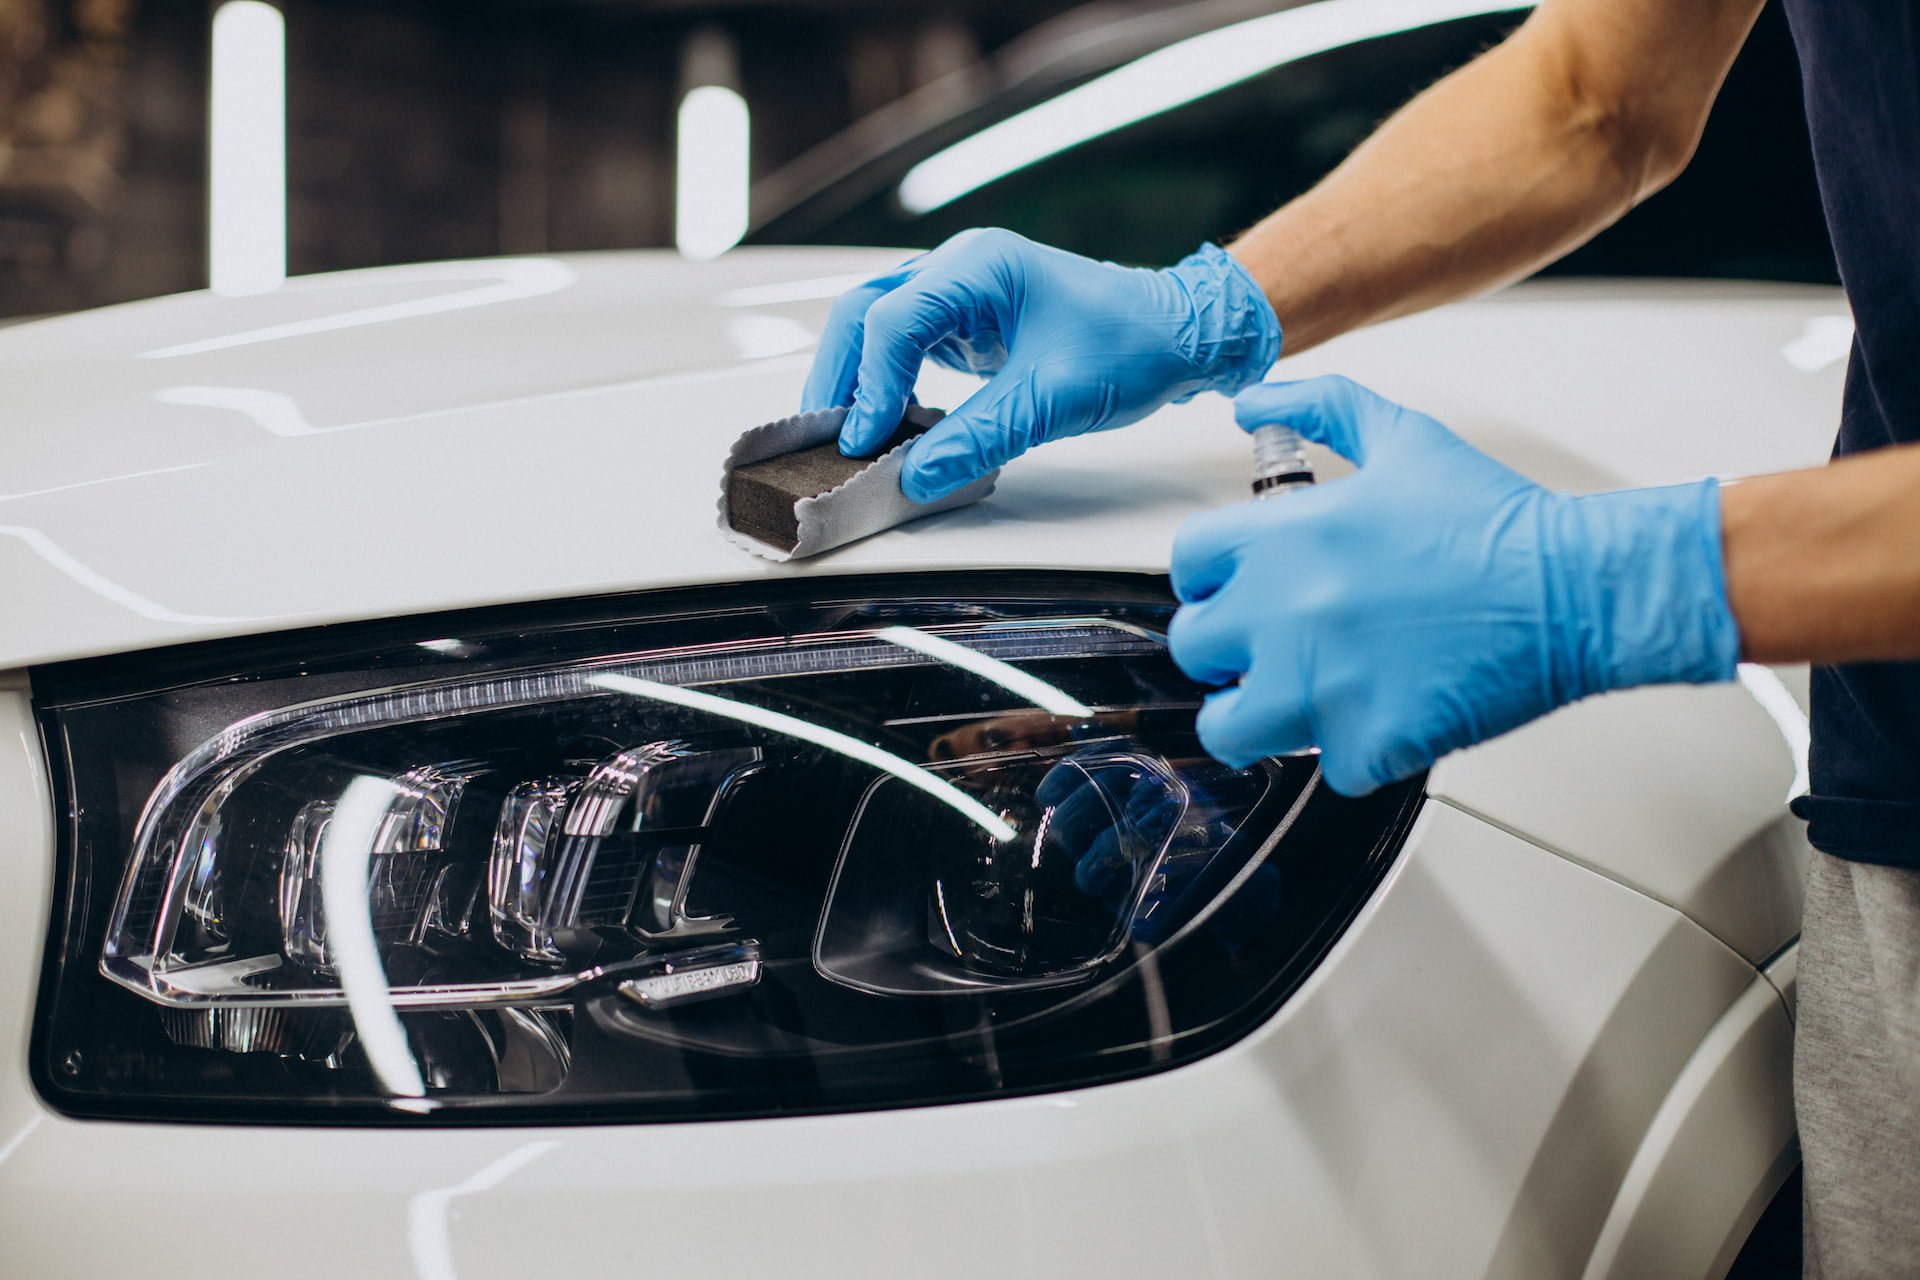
[801,0,1763,503]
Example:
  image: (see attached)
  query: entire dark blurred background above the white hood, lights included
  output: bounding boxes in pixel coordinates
[0,0,1836,319]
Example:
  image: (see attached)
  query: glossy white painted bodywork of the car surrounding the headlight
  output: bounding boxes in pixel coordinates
[0,249,1845,1280]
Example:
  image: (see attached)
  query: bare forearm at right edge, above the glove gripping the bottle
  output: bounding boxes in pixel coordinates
[1720,445,1920,662]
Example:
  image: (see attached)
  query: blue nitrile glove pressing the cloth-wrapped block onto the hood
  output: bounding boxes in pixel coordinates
[801,228,1281,503]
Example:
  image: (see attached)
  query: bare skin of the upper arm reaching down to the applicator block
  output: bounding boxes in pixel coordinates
[1229,0,1763,353]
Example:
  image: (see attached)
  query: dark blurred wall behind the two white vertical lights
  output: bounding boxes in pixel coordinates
[0,0,1071,317]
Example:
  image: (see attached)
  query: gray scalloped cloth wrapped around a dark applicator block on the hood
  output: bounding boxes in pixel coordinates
[720,405,1000,560]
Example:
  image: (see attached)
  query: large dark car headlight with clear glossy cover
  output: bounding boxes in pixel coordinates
[33,574,1421,1123]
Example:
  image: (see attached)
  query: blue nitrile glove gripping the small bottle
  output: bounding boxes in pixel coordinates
[1169,378,1740,794]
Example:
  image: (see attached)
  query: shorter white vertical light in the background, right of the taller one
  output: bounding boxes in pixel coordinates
[674,31,753,259]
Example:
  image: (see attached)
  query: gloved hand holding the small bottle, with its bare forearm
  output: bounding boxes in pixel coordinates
[1167,378,1920,794]
